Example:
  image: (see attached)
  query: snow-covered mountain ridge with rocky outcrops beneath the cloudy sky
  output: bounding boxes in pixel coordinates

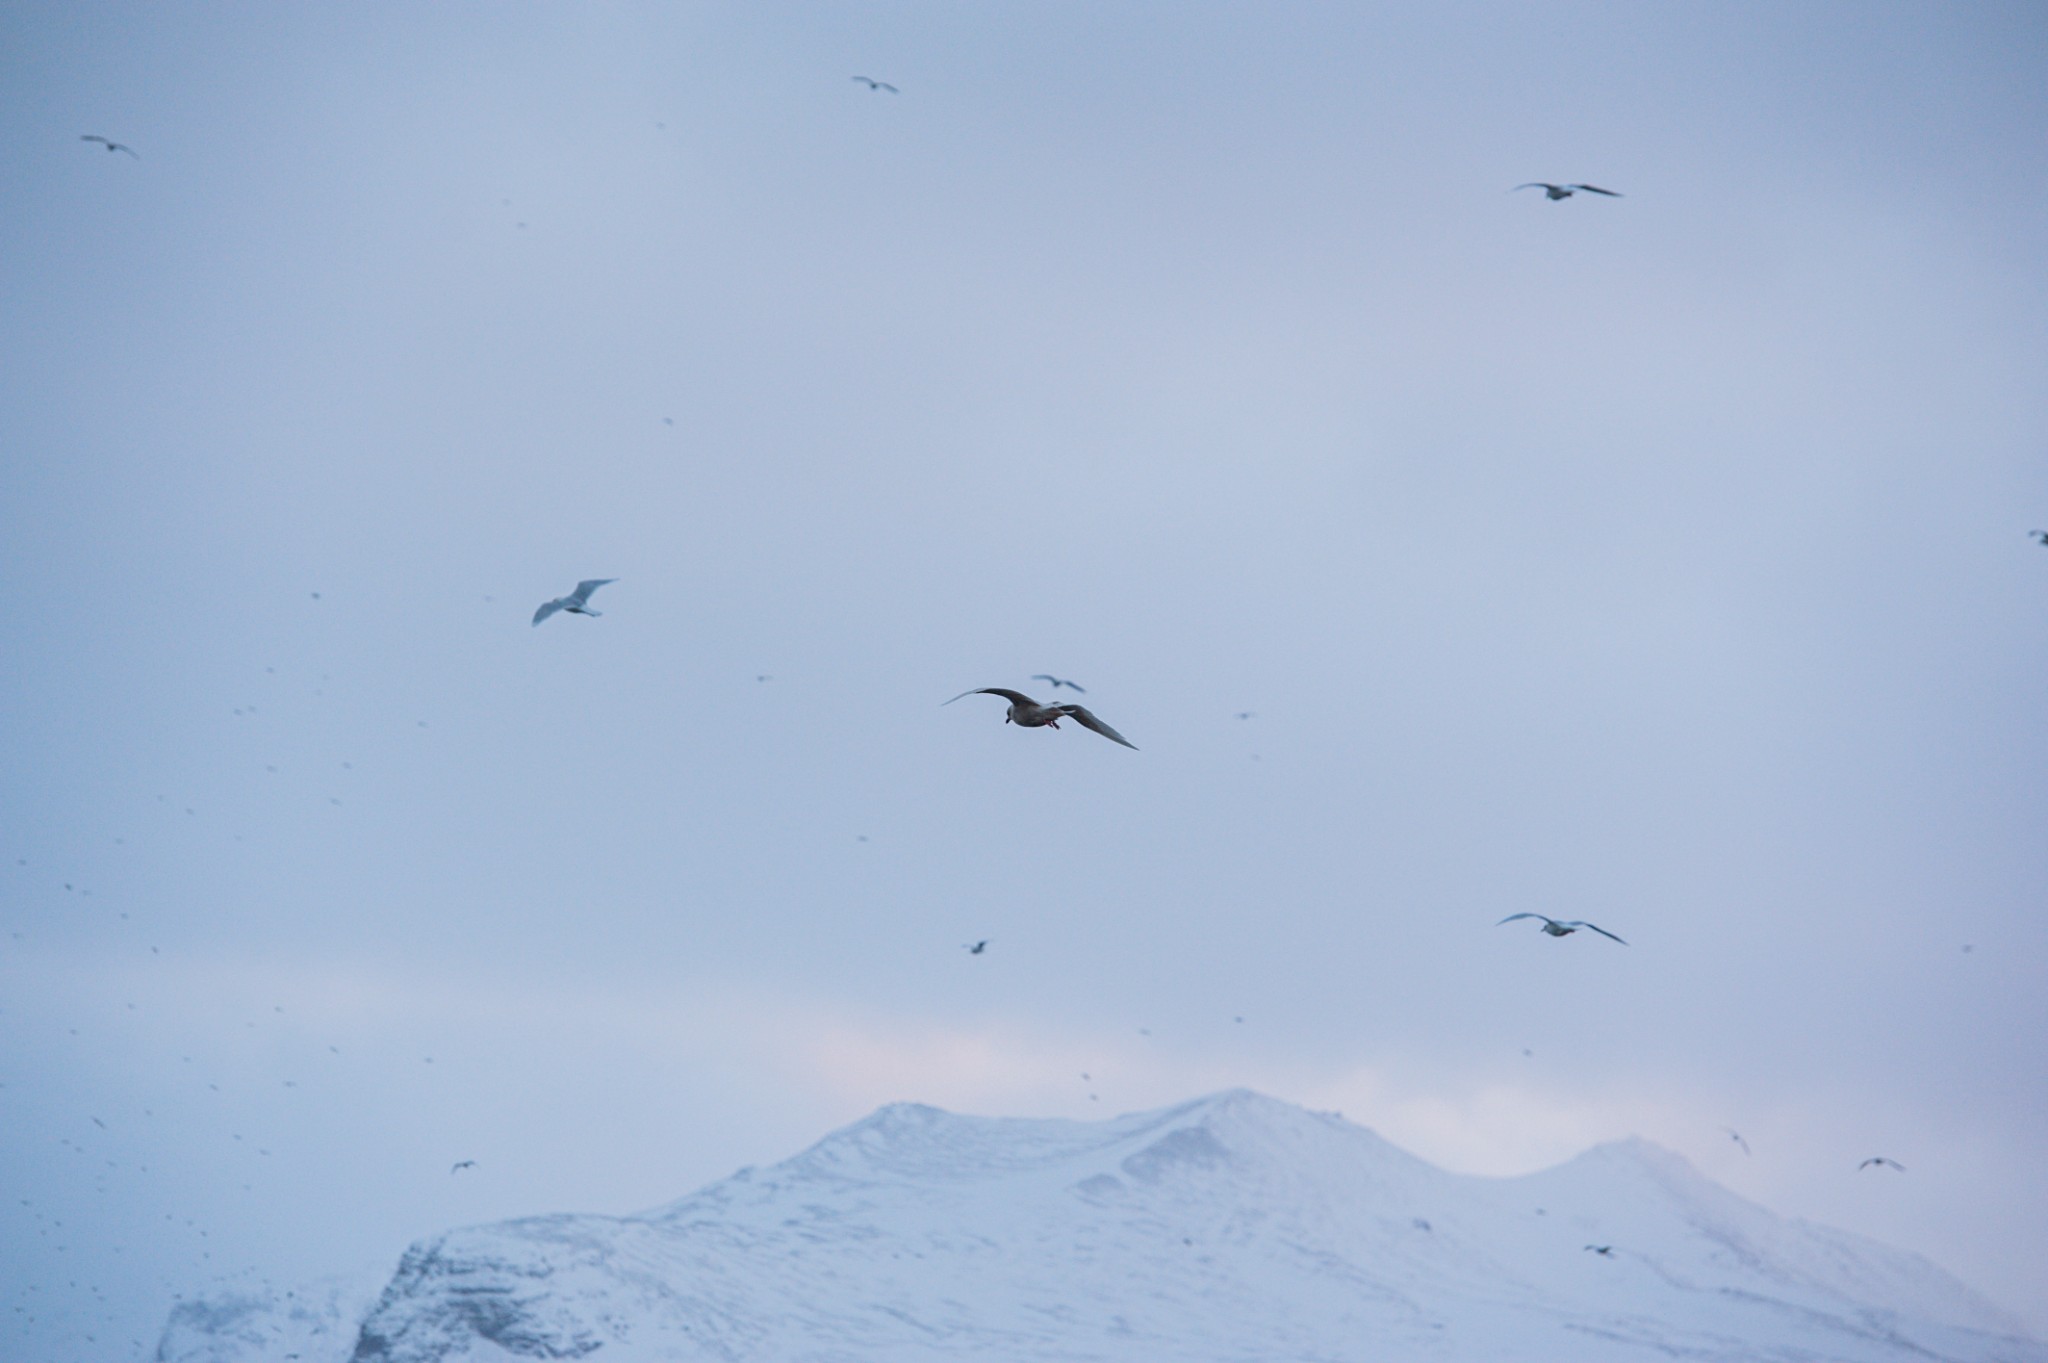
[158,1091,2048,1363]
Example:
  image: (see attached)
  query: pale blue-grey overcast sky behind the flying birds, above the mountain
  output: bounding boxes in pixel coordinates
[0,0,2048,1363]
